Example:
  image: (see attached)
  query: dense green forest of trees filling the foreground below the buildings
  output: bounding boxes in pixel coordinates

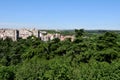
[0,29,120,80]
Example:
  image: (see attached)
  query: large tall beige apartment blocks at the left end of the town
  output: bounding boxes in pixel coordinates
[0,29,39,41]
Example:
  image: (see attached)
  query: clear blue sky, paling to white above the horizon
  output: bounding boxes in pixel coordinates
[0,0,120,30]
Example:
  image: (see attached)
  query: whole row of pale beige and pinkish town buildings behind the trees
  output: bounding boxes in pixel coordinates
[0,29,74,41]
